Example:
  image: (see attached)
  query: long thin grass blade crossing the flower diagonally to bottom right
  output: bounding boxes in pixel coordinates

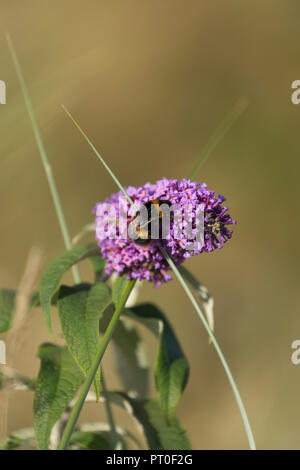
[62,111,256,450]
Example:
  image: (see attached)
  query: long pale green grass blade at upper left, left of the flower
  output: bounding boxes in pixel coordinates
[5,33,80,283]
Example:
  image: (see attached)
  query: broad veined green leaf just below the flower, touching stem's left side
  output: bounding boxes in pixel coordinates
[57,283,111,399]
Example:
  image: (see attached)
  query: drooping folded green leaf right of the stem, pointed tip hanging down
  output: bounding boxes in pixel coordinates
[126,303,189,421]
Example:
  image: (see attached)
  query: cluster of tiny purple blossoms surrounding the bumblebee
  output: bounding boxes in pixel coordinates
[93,178,236,286]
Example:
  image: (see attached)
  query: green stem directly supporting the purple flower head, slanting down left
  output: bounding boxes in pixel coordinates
[58,280,135,450]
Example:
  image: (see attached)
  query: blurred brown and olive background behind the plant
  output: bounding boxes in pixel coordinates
[0,0,300,449]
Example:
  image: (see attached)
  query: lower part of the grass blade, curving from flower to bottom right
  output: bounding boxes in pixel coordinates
[160,248,256,450]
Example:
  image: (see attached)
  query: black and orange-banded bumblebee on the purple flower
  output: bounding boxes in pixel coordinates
[128,199,171,247]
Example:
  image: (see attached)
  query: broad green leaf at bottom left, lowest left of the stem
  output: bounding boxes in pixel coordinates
[34,343,83,450]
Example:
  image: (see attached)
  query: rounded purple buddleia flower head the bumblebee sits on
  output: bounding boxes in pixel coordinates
[93,178,236,286]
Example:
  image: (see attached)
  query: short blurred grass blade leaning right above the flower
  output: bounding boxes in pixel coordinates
[188,98,248,180]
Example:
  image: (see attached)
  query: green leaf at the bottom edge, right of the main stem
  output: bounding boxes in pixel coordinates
[109,392,191,450]
